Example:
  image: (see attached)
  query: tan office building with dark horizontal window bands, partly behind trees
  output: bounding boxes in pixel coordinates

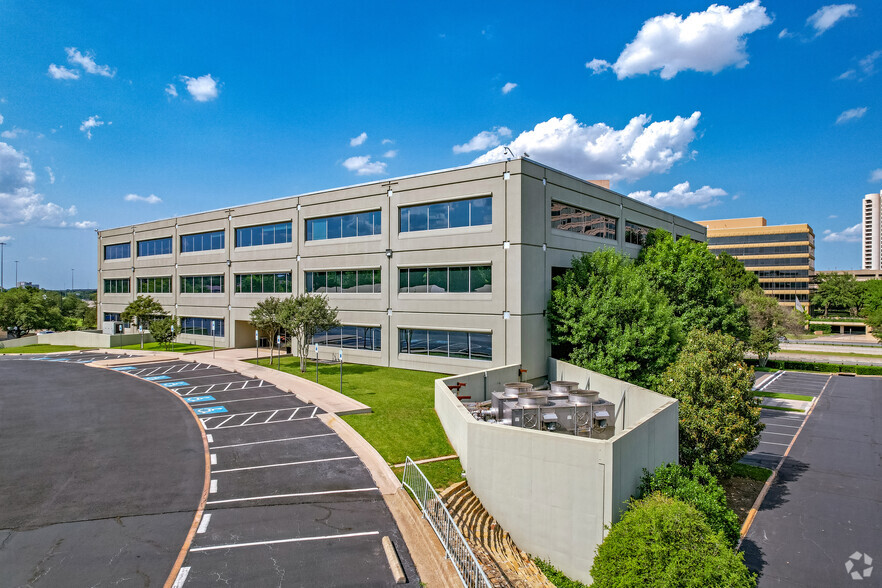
[697,216,815,308]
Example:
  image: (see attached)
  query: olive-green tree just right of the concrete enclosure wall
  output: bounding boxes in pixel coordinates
[658,330,764,475]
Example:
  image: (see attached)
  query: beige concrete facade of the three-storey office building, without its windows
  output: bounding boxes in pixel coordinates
[98,159,705,377]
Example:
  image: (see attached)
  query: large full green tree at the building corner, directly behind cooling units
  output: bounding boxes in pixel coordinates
[546,249,682,387]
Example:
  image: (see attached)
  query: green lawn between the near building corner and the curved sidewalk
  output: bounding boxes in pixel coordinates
[249,356,462,488]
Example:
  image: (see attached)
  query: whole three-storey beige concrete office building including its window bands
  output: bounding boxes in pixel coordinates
[98,159,705,378]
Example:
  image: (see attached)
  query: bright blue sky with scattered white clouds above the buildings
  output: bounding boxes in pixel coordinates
[0,0,882,288]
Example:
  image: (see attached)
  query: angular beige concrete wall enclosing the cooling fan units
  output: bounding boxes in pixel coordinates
[435,360,678,583]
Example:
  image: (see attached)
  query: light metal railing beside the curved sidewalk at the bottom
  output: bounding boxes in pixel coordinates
[401,457,492,588]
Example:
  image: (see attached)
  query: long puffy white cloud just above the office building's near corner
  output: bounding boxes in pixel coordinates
[474,111,701,180]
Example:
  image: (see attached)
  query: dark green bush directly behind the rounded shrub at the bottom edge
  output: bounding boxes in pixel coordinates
[638,463,740,547]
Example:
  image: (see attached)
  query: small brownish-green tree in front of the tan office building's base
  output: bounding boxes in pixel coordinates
[738,290,805,366]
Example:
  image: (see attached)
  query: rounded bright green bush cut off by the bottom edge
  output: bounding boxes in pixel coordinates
[591,494,756,588]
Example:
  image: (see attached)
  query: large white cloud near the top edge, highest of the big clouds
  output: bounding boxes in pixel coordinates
[586,0,772,80]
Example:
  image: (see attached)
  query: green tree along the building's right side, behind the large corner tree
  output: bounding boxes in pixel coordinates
[637,229,748,338]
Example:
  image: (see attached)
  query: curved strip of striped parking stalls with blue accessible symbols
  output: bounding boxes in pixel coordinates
[112,361,419,586]
